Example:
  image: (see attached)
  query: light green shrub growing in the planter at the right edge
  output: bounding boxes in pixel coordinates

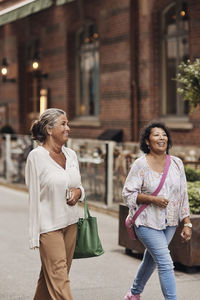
[187,181,200,215]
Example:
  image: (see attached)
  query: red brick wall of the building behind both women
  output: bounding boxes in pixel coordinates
[0,0,200,145]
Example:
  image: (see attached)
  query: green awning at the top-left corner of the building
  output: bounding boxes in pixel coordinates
[0,0,53,26]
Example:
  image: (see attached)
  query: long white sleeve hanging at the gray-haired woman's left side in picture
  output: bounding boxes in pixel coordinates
[25,155,40,249]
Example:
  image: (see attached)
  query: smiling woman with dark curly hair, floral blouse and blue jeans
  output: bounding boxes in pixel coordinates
[123,123,192,300]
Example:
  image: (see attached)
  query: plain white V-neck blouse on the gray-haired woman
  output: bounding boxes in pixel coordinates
[25,146,85,248]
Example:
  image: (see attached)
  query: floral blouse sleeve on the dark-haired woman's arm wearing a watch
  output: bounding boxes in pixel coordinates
[179,160,190,221]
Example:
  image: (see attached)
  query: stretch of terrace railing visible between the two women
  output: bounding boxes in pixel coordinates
[68,139,140,207]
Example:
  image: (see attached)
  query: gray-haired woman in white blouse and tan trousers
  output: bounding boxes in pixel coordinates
[25,108,84,300]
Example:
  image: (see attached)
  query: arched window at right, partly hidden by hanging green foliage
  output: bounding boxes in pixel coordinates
[161,0,189,117]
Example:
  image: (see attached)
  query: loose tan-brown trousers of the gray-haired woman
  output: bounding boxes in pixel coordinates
[34,224,77,300]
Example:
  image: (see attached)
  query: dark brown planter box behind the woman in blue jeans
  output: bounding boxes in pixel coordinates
[119,204,200,268]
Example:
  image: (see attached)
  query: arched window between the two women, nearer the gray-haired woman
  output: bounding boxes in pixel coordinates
[76,21,99,117]
